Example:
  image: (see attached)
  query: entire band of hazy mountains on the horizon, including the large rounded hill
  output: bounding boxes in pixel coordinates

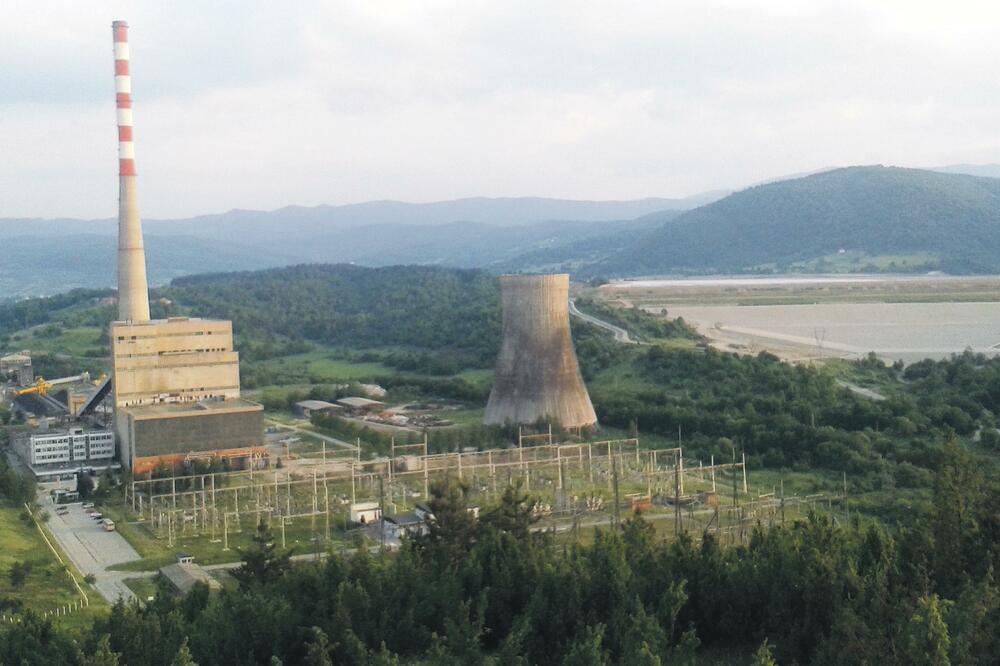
[0,165,1000,300]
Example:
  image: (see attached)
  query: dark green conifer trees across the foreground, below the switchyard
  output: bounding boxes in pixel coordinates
[0,441,1000,666]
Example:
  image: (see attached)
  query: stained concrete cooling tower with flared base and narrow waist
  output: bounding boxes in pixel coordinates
[483,274,597,428]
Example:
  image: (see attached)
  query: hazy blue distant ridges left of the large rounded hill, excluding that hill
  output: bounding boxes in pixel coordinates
[0,192,723,299]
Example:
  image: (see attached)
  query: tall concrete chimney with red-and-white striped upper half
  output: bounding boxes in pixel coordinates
[111,21,149,321]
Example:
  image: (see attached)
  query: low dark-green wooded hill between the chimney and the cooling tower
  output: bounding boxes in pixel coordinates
[167,264,500,358]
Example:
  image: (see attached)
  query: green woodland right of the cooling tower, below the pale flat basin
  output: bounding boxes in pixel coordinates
[592,346,1000,496]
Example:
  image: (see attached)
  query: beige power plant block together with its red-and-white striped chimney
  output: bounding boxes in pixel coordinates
[111,21,263,473]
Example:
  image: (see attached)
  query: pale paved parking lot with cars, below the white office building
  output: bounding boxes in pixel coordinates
[38,488,144,603]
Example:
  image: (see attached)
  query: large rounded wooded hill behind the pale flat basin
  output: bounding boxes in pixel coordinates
[585,166,1000,275]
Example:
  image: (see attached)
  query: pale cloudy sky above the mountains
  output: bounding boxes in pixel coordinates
[0,0,1000,217]
